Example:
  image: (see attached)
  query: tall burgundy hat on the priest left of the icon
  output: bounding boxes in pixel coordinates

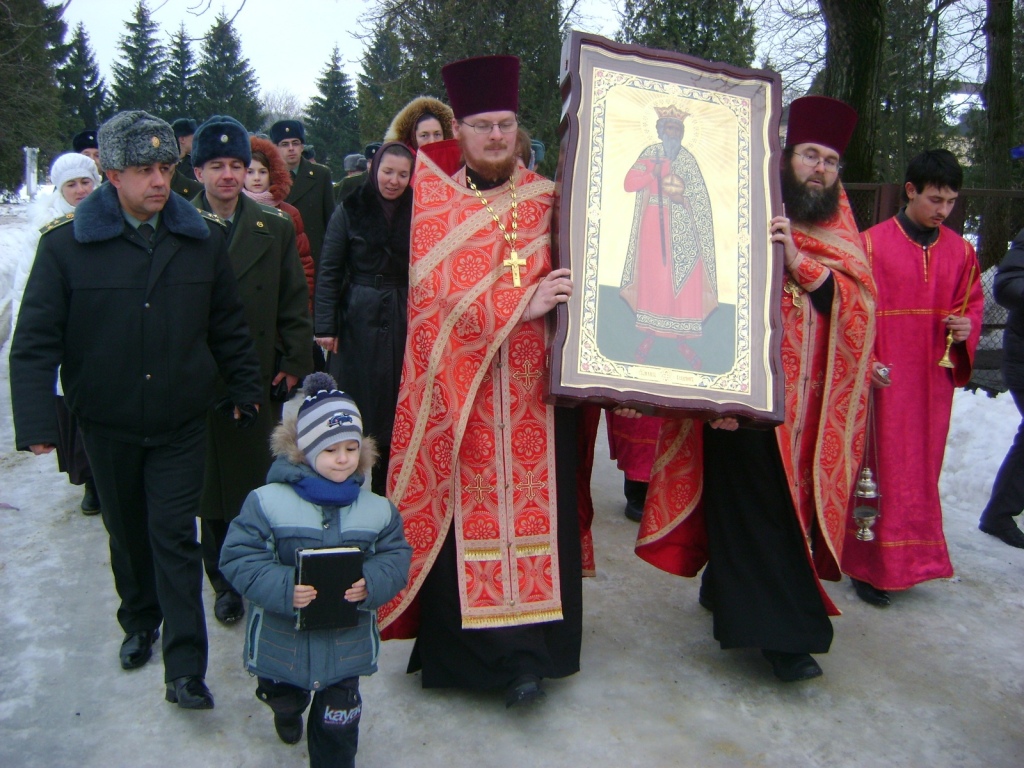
[441,56,519,120]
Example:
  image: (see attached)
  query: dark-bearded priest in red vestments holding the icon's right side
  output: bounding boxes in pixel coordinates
[636,96,874,682]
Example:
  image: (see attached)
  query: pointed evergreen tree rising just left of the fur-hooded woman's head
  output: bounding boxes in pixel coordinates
[356,22,413,144]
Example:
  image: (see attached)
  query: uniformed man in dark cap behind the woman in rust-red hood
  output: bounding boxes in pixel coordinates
[270,120,334,265]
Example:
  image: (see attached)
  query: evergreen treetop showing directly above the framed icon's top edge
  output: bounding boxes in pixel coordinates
[618,0,754,67]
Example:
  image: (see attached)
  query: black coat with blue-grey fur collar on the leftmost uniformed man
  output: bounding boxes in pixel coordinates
[10,184,262,449]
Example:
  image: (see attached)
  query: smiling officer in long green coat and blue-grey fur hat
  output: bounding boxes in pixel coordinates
[193,115,313,624]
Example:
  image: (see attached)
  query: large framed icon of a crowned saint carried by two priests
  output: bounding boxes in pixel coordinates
[550,32,784,423]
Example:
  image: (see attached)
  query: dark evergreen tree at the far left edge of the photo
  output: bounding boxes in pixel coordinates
[0,0,67,191]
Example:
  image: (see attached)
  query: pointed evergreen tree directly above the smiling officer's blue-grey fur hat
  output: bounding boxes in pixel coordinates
[195,12,262,130]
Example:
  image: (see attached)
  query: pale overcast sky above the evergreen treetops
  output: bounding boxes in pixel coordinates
[59,0,617,104]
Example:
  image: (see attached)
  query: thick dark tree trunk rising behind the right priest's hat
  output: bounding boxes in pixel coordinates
[819,0,886,181]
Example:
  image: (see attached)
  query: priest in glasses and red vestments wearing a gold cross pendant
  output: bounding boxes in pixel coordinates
[380,56,583,707]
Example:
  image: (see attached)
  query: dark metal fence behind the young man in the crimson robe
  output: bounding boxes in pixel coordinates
[844,184,1024,395]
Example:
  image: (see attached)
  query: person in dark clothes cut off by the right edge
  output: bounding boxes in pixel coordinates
[978,229,1024,549]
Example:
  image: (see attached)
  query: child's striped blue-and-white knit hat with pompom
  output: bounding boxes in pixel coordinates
[297,373,362,467]
